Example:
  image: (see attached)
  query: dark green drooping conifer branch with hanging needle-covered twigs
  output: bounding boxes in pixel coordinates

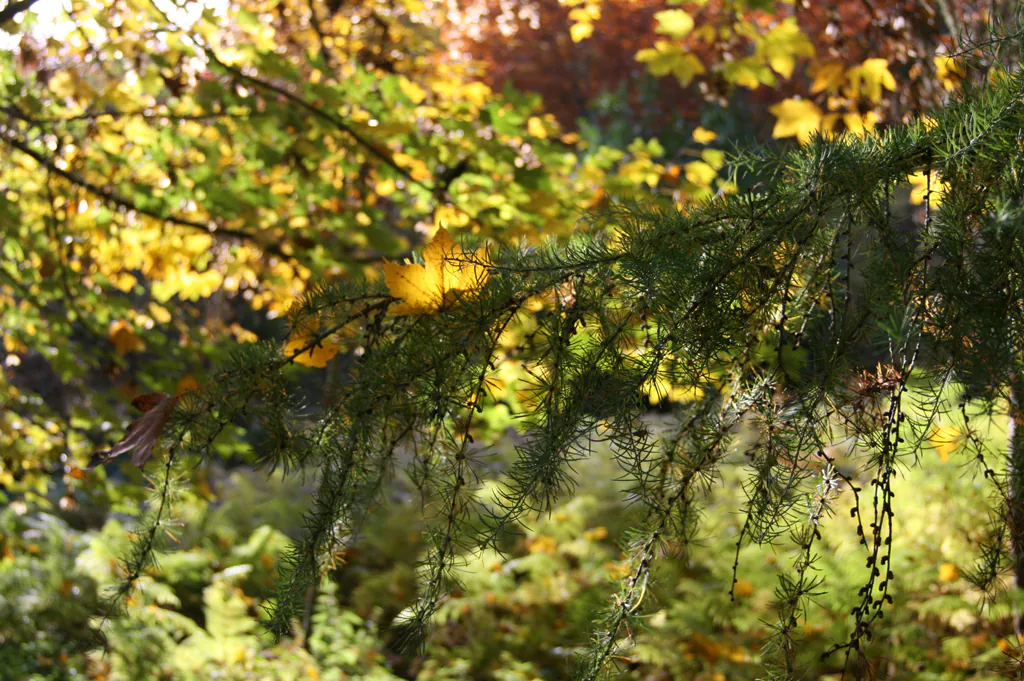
[116,18,1024,681]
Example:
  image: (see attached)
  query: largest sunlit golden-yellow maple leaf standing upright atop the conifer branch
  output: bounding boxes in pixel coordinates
[384,227,487,314]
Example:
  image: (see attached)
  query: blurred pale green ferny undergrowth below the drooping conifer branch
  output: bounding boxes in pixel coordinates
[0,403,1020,681]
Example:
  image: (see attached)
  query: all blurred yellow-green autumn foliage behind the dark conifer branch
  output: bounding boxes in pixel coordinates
[0,0,1018,681]
